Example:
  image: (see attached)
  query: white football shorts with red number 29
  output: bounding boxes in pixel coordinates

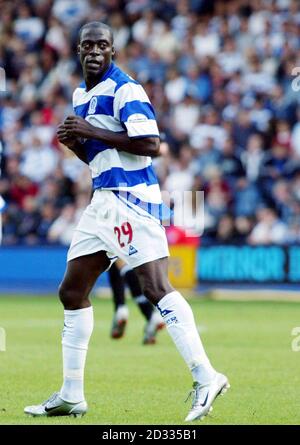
[67,190,169,268]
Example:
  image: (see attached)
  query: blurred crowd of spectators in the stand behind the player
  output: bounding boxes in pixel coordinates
[0,0,300,245]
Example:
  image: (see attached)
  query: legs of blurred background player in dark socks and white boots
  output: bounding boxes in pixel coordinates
[108,259,164,345]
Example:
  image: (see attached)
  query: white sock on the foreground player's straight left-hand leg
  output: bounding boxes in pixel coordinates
[60,306,94,403]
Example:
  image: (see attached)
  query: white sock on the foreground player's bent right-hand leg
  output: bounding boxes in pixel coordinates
[157,291,216,384]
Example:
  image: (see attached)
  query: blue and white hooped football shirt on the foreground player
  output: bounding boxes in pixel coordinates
[73,63,162,205]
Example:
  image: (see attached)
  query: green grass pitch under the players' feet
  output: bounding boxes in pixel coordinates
[0,296,300,425]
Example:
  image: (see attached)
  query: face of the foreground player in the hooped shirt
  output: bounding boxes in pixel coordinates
[78,27,114,77]
